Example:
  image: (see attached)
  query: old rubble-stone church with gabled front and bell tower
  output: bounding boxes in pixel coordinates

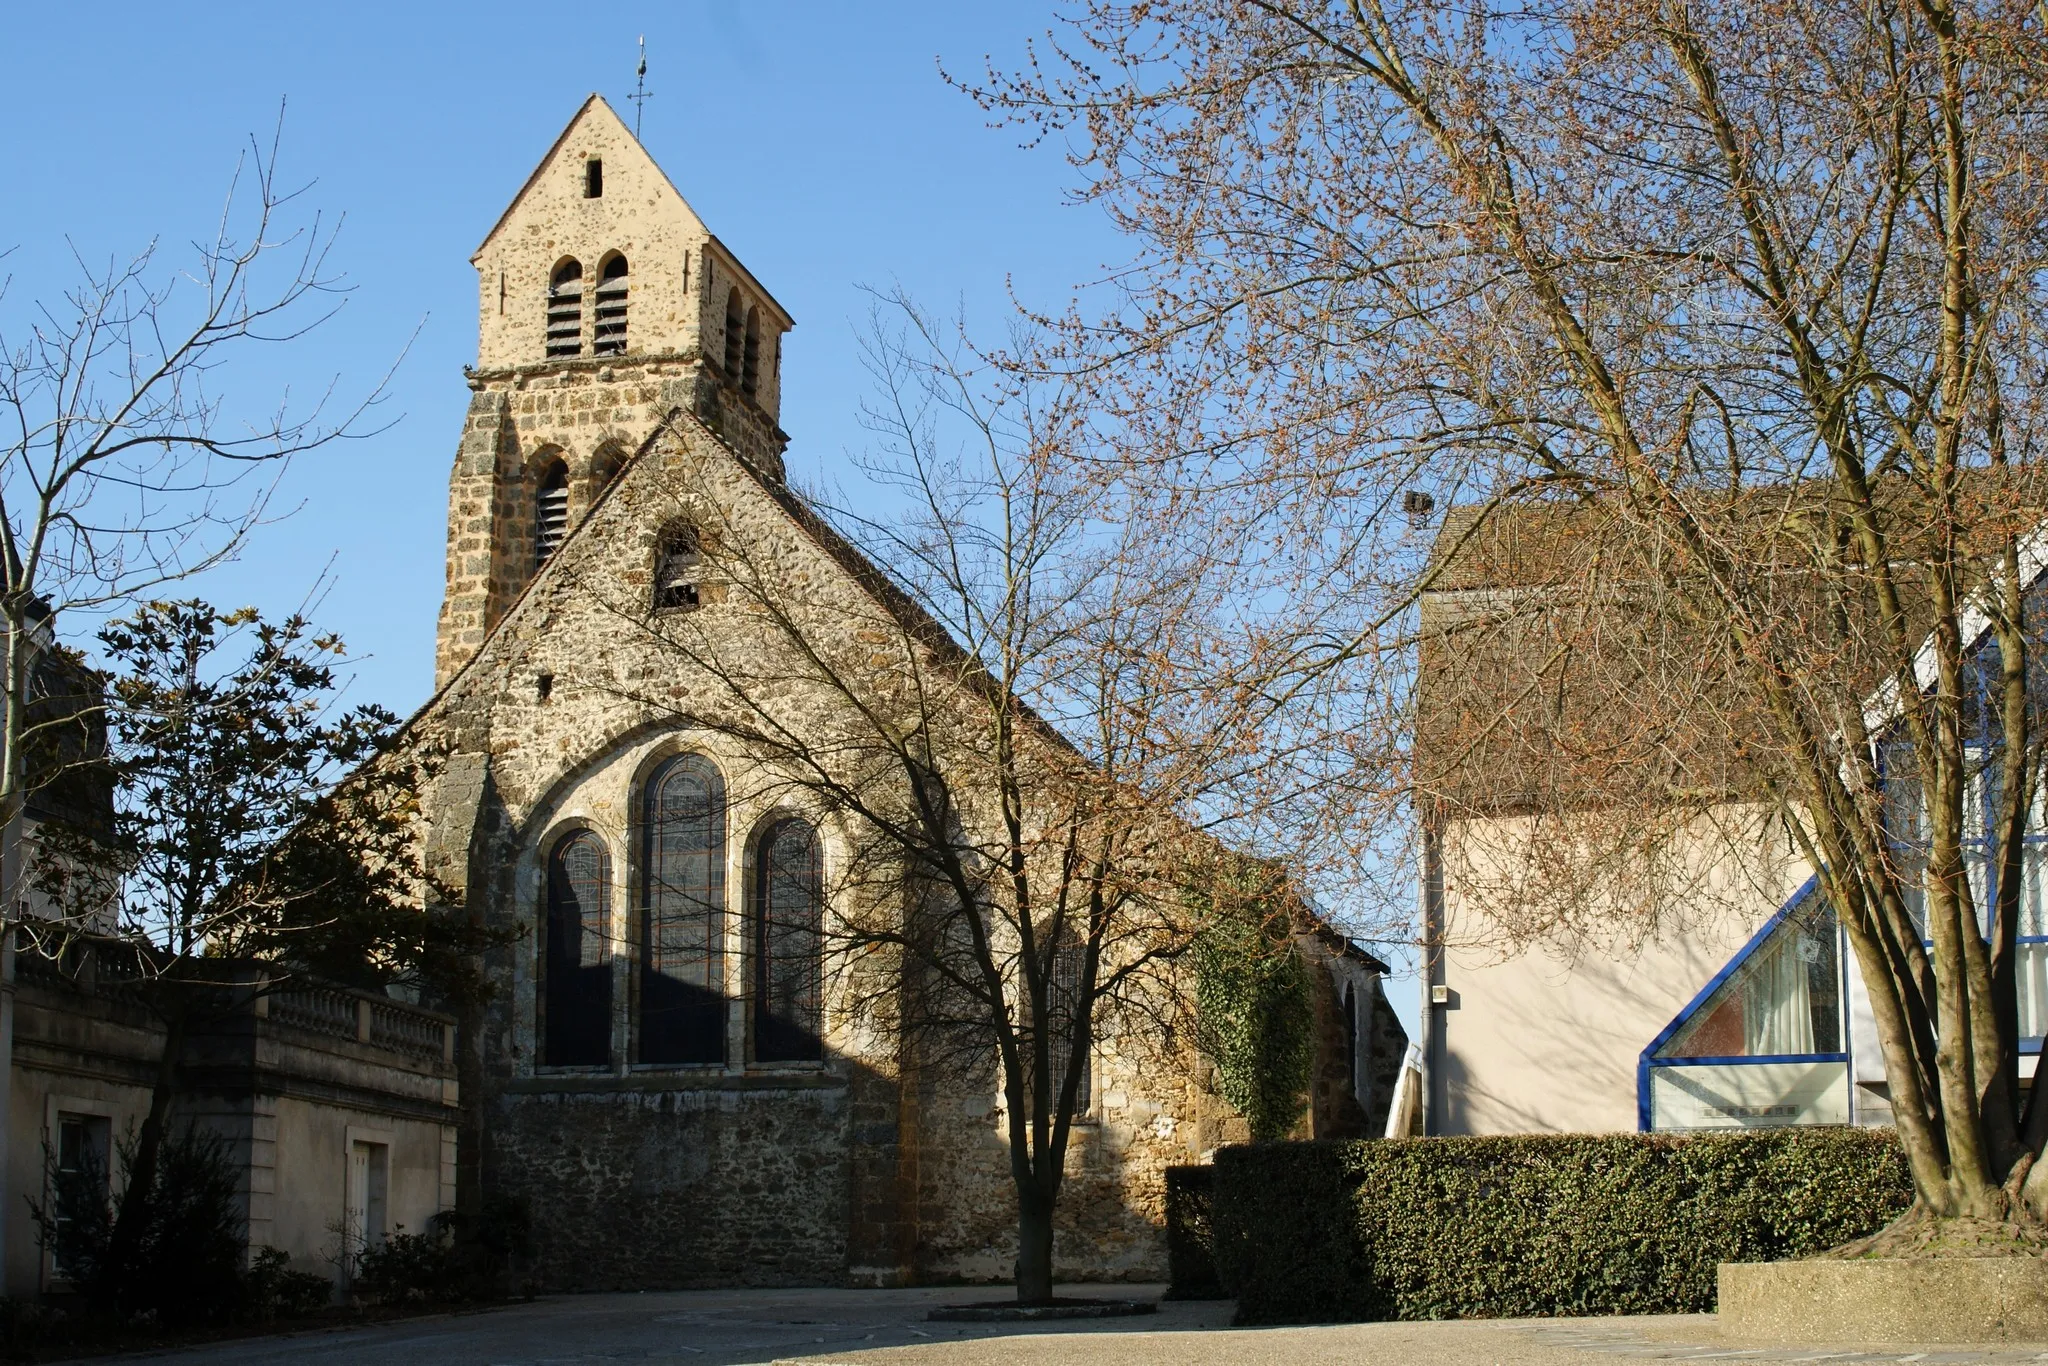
[406,96,1405,1290]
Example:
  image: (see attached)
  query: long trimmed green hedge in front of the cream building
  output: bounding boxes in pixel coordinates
[1196,1128,1913,1323]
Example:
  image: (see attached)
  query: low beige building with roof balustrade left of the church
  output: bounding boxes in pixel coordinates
[4,950,461,1296]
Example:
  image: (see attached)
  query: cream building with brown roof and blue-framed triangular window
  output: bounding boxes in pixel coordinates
[1417,508,2048,1135]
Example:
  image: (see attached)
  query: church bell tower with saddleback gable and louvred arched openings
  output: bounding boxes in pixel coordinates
[434,94,795,688]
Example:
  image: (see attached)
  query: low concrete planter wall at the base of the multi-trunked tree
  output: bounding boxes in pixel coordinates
[1720,1257,2048,1343]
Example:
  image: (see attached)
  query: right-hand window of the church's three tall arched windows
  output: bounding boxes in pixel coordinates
[752,817,825,1063]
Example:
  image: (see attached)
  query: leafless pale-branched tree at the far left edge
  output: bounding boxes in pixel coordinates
[0,119,395,924]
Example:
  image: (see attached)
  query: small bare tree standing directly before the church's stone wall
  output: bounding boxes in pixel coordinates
[612,299,1376,1303]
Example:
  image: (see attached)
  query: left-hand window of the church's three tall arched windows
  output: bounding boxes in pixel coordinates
[541,829,612,1067]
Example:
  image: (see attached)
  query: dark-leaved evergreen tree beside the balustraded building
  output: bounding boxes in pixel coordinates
[31,602,492,1309]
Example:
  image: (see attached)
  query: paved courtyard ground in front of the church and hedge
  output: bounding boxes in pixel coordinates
[127,1286,2048,1366]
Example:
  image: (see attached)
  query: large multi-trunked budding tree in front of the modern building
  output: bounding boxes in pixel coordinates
[973,0,2048,1243]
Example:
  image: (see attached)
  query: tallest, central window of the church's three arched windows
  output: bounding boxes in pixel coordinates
[639,754,725,1063]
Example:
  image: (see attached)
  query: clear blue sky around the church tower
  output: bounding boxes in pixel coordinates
[0,2,1122,713]
